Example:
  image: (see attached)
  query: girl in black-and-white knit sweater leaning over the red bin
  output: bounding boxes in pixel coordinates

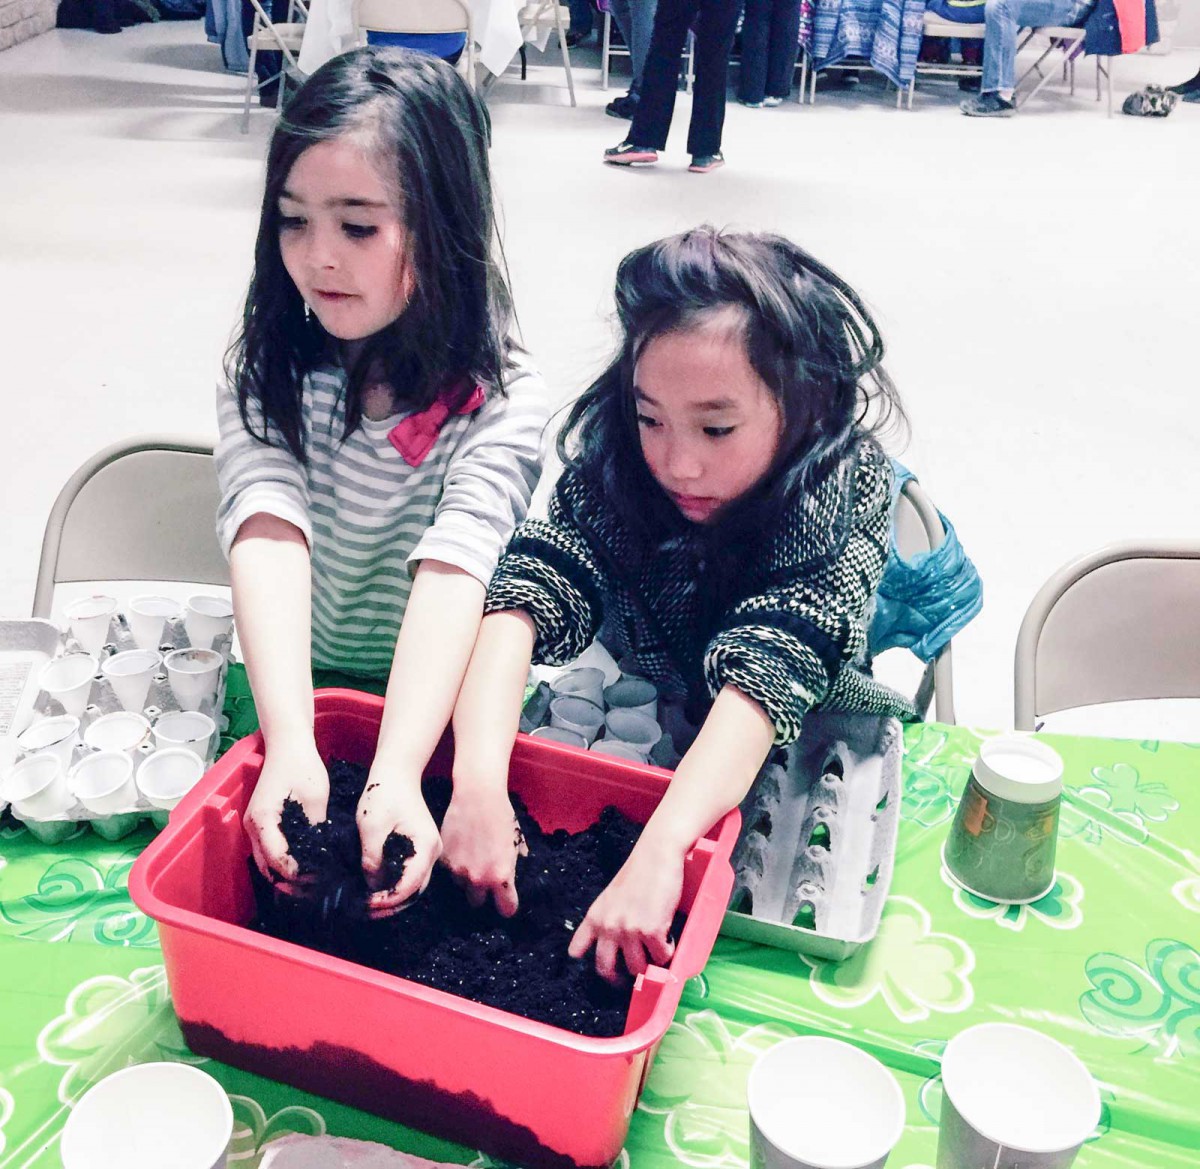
[442,227,911,979]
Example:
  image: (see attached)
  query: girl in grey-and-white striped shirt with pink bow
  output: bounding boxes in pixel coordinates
[217,48,548,913]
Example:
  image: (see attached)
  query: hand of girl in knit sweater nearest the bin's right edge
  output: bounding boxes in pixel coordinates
[568,837,684,983]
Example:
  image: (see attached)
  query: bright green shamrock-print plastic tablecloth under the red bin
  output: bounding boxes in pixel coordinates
[0,710,1200,1169]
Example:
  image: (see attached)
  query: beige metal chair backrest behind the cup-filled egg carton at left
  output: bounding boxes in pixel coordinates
[34,437,229,617]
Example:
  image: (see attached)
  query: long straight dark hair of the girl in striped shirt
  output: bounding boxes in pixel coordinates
[226,48,512,461]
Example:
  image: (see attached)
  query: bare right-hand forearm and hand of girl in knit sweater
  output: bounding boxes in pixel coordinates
[569,687,775,981]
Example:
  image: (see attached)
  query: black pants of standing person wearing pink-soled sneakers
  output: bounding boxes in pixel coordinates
[629,0,743,155]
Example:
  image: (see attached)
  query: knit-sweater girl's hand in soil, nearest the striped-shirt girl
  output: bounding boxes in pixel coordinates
[442,786,529,917]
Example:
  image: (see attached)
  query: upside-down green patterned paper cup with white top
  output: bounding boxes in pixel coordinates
[942,735,1062,905]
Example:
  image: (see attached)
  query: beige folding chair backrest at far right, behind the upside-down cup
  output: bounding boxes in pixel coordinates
[1014,540,1200,731]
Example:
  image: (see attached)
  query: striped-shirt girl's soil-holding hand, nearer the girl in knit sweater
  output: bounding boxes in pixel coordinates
[358,771,442,917]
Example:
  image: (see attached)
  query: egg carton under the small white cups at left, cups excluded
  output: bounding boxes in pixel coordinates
[0,613,233,844]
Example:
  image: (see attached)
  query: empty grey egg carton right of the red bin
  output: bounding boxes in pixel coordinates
[721,712,902,960]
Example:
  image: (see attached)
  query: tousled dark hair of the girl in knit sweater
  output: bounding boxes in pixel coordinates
[558,226,904,542]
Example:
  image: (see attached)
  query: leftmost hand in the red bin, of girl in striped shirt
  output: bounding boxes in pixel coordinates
[241,735,329,897]
